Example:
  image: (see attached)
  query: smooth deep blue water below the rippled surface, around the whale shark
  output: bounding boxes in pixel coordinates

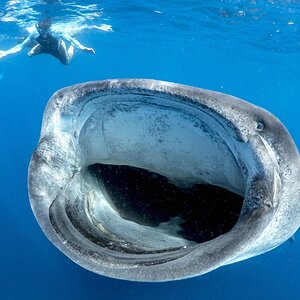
[0,1,300,300]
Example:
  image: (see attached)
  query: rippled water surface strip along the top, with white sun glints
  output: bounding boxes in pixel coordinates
[0,0,300,53]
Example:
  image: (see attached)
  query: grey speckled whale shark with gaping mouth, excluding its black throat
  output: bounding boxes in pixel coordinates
[28,79,300,281]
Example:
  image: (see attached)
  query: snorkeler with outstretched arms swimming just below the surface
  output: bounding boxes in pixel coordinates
[0,19,95,65]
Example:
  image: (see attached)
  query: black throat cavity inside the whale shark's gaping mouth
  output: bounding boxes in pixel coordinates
[88,164,243,243]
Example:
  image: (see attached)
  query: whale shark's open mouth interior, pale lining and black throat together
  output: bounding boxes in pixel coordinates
[50,93,244,254]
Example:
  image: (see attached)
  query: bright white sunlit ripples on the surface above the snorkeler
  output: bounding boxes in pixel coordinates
[0,0,113,36]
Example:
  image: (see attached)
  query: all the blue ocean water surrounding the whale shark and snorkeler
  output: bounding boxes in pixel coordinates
[0,0,300,300]
